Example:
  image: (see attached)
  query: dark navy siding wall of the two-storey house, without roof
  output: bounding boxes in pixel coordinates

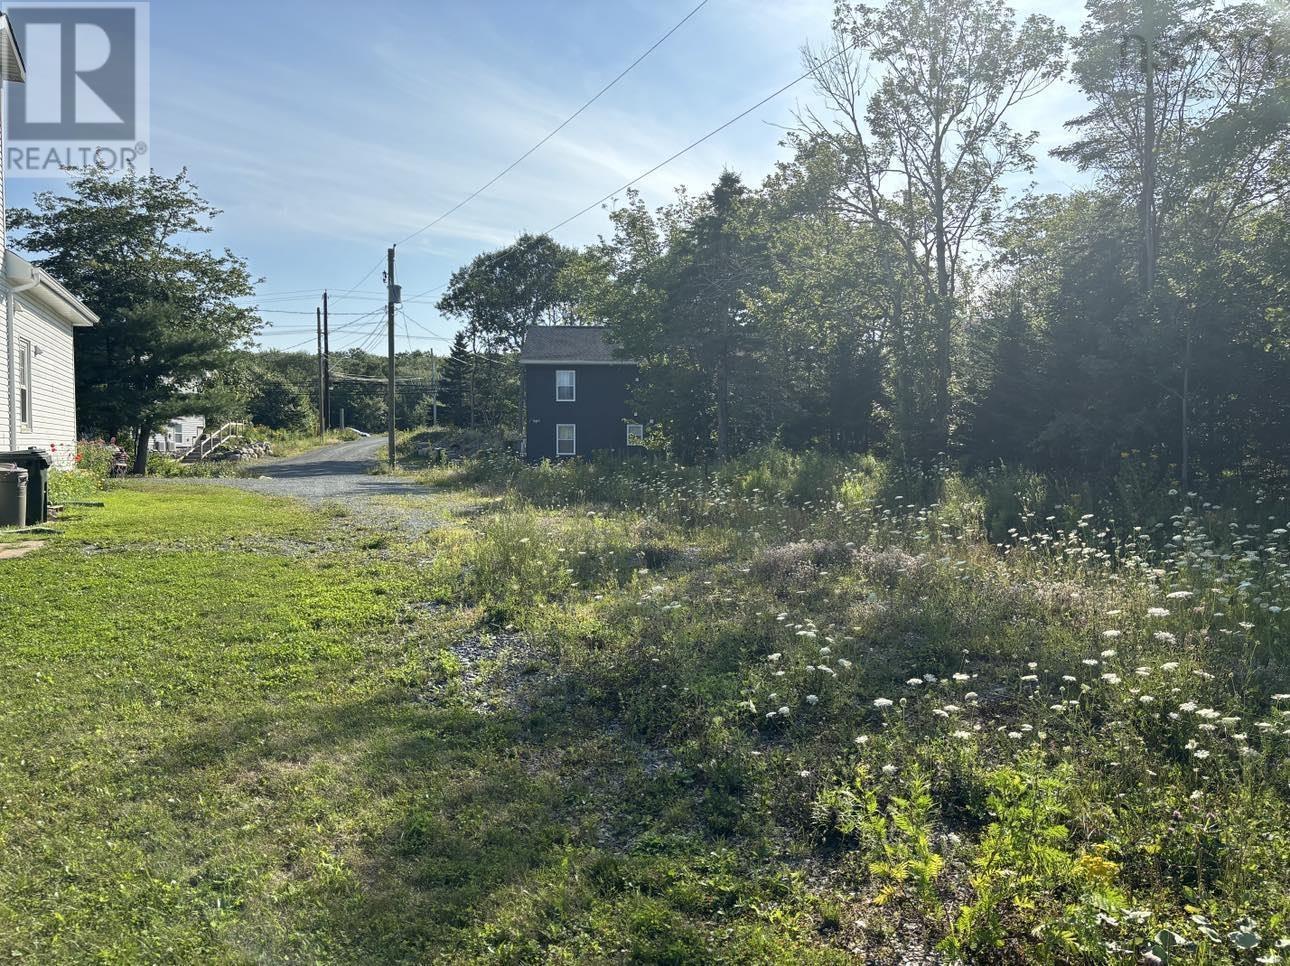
[524,364,644,462]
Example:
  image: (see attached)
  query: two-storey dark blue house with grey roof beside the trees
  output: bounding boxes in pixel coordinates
[520,325,645,462]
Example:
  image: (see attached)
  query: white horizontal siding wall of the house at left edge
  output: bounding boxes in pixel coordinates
[0,285,76,467]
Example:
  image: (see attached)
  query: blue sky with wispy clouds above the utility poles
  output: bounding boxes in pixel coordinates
[9,0,1082,351]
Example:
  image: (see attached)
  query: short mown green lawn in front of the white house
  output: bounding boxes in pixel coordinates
[0,485,825,963]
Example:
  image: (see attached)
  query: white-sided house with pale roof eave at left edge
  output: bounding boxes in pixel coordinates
[0,14,98,467]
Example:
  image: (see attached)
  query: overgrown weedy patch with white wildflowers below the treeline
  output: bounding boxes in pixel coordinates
[420,450,1290,962]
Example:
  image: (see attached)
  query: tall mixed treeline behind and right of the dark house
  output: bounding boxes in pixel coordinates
[440,0,1290,484]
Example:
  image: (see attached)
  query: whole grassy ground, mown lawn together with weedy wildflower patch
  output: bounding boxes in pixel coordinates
[0,453,1290,963]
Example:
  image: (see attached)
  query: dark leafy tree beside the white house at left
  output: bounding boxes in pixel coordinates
[10,168,259,473]
